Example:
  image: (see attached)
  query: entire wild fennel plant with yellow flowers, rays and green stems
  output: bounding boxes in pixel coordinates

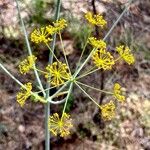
[0,0,135,150]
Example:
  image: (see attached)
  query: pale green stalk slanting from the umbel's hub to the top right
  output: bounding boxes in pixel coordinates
[74,0,132,77]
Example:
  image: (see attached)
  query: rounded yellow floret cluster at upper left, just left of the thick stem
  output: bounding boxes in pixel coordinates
[31,27,52,44]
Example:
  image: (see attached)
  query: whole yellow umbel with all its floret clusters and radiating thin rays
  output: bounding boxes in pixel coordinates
[14,12,135,137]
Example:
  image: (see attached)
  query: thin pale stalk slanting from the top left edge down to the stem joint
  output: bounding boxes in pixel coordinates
[16,0,46,97]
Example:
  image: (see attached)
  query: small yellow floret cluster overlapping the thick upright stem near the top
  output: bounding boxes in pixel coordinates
[53,19,67,31]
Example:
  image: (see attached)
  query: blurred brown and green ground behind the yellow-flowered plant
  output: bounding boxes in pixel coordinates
[0,0,150,150]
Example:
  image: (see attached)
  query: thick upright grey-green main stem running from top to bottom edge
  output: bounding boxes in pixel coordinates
[45,0,61,150]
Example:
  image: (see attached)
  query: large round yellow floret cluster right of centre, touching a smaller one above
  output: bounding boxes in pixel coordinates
[92,49,115,70]
